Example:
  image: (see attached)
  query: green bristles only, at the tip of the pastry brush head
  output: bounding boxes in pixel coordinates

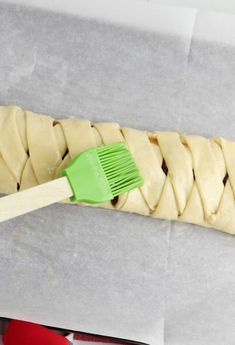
[97,142,143,197]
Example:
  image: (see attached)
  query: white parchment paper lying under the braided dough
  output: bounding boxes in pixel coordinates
[0,3,235,345]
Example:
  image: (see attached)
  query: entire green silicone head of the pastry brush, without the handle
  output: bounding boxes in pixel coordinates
[61,142,143,204]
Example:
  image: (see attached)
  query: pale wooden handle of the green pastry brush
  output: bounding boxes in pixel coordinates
[0,177,73,222]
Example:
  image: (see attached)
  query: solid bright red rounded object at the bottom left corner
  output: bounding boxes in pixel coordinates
[2,320,69,345]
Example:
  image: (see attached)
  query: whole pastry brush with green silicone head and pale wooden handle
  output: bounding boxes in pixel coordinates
[0,142,143,222]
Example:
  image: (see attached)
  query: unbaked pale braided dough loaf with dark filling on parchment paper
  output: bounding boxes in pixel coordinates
[0,106,235,234]
